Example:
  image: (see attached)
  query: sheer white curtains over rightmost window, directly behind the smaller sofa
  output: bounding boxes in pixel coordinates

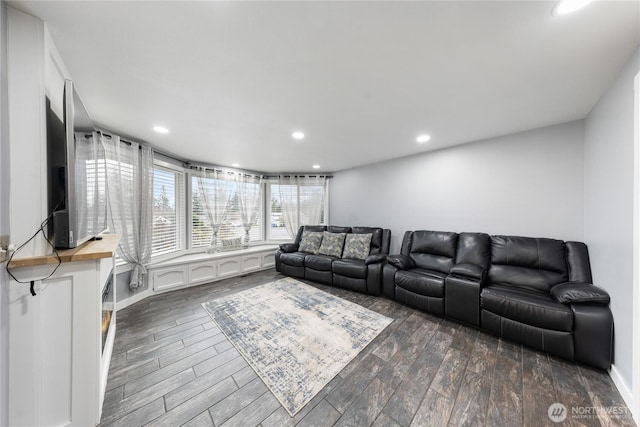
[278,176,327,239]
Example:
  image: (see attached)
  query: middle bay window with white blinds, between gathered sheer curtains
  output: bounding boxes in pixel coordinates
[191,176,264,248]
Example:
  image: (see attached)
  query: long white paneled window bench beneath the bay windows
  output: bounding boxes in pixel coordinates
[147,245,278,293]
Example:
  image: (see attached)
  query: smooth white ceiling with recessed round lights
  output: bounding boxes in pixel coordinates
[9,1,640,172]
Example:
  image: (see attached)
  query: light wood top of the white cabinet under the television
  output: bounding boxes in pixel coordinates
[8,234,120,268]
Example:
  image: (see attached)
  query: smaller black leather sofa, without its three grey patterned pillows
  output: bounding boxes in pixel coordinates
[275,225,391,295]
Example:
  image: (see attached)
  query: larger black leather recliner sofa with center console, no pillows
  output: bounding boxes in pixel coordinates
[383,231,613,369]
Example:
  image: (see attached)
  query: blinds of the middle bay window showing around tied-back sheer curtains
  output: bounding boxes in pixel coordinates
[191,176,264,248]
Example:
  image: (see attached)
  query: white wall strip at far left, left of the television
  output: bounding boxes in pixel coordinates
[7,7,47,256]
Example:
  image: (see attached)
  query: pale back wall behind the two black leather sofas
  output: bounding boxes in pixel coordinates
[329,121,584,252]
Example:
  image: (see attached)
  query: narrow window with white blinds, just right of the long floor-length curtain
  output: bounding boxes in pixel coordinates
[151,165,186,256]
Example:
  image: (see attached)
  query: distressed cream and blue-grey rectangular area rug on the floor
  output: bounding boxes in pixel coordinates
[202,278,393,416]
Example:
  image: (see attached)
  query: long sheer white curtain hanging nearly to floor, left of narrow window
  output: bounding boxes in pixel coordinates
[101,136,153,289]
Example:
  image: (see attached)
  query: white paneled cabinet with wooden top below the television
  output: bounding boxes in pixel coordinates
[8,236,119,427]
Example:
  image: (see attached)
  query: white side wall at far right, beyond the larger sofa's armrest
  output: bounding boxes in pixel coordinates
[584,47,640,418]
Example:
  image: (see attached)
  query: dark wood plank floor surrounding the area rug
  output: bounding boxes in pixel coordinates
[100,270,635,427]
